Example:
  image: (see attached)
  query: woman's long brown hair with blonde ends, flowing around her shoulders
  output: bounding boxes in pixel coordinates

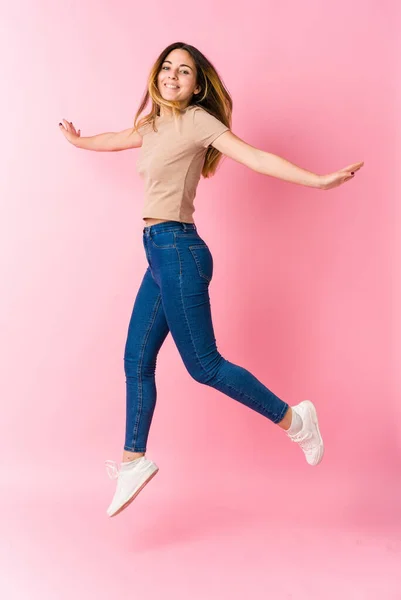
[134,42,233,177]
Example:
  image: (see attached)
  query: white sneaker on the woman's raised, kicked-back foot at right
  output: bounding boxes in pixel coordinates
[288,400,324,466]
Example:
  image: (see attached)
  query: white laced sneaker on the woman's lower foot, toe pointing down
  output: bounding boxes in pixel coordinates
[105,456,159,517]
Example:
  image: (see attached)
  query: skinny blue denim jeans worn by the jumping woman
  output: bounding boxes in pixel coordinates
[124,221,288,452]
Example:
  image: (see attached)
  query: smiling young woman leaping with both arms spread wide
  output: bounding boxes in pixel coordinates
[59,42,363,516]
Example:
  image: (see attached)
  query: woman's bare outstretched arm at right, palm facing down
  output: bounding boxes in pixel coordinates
[211,131,364,190]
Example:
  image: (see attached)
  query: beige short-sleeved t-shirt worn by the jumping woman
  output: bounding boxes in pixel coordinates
[136,105,229,223]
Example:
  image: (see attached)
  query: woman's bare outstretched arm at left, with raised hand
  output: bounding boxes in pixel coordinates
[59,119,142,152]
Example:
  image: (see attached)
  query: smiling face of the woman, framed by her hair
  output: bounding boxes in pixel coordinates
[157,48,200,108]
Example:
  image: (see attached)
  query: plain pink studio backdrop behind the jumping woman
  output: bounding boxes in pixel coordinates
[0,0,401,600]
